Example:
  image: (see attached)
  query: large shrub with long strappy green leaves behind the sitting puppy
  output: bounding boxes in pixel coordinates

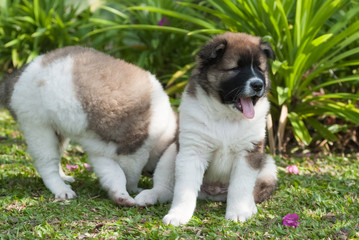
[121,0,359,152]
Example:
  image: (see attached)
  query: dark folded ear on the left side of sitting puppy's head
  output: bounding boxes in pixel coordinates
[198,39,227,64]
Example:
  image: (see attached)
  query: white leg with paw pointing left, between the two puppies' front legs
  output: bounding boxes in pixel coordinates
[135,143,177,206]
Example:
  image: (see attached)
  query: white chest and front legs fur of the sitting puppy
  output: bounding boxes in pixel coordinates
[163,88,273,226]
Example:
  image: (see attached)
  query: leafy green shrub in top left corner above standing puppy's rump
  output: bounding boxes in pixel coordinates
[0,0,90,69]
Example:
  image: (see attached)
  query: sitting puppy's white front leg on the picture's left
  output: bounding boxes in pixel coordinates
[163,151,209,226]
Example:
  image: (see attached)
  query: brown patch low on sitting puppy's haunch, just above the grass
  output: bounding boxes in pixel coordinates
[253,178,277,203]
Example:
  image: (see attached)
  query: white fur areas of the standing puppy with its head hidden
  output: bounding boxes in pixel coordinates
[10,53,176,202]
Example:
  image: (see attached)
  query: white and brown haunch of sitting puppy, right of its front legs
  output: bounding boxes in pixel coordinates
[253,155,277,203]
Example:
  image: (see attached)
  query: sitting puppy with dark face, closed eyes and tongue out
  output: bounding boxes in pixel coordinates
[136,33,277,226]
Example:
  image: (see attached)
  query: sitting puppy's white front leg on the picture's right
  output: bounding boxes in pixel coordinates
[226,158,258,222]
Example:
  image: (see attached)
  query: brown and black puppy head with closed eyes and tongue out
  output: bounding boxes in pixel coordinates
[193,32,275,119]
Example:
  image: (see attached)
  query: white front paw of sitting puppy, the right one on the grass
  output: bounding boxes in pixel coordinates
[226,202,257,222]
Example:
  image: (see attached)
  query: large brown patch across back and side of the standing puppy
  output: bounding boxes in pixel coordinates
[43,47,152,154]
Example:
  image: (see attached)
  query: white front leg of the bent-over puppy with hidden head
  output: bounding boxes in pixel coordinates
[89,155,135,206]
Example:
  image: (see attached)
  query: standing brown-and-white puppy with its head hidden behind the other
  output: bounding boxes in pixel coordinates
[0,46,177,205]
